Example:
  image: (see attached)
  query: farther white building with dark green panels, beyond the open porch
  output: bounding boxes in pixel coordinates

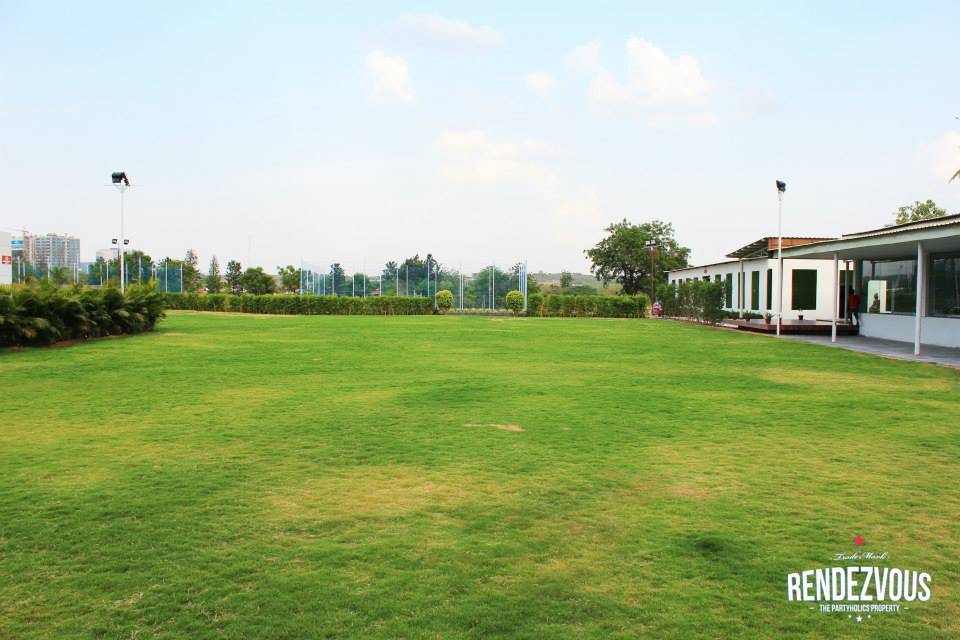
[667,237,852,321]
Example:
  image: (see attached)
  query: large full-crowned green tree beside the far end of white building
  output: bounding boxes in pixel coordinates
[584,219,690,300]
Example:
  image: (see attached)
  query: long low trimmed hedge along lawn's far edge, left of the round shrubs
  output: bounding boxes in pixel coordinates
[166,293,433,316]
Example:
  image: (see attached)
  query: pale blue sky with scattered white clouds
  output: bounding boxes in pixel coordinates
[0,0,960,272]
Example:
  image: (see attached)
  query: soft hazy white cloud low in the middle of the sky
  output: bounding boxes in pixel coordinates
[435,131,560,191]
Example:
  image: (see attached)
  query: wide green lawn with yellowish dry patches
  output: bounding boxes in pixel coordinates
[0,312,960,639]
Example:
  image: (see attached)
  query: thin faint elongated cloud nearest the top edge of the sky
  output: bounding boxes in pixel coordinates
[383,15,503,51]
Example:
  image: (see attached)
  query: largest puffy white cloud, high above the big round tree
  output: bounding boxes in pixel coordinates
[567,36,715,124]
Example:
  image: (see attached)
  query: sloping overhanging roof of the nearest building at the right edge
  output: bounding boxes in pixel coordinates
[783,214,960,260]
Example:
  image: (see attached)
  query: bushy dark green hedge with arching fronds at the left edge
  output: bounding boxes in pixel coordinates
[0,284,163,347]
